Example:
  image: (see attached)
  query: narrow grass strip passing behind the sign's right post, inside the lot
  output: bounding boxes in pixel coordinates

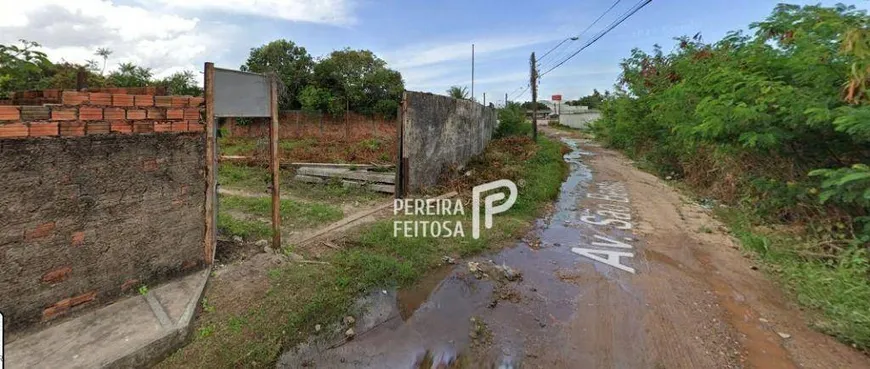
[218,195,344,226]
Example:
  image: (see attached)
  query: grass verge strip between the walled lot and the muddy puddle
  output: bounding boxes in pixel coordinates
[160,138,568,368]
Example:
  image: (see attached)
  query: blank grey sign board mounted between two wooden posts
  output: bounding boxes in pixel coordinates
[214,68,272,118]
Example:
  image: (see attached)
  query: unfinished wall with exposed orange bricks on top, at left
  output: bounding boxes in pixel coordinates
[0,91,206,331]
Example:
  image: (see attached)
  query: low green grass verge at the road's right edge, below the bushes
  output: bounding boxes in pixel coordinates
[717,209,870,351]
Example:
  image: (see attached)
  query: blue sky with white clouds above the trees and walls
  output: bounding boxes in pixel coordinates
[0,0,868,103]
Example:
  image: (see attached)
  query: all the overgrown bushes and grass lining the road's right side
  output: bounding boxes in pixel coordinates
[592,4,870,349]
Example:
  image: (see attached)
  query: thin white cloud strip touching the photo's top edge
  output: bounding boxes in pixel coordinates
[157,0,356,25]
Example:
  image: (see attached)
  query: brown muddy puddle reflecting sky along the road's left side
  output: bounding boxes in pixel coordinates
[278,139,628,369]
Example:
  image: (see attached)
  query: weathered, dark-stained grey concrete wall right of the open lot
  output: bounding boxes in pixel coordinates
[401,91,498,193]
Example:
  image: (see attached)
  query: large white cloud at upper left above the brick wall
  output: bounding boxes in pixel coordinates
[0,0,238,77]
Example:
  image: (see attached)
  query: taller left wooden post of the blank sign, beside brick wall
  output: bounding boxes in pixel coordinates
[203,63,218,265]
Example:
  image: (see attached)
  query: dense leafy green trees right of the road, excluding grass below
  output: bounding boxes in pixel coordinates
[593,4,870,236]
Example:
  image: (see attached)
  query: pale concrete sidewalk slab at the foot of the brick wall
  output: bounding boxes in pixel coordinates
[5,269,210,369]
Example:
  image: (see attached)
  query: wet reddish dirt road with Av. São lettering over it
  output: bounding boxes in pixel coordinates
[278,128,870,368]
